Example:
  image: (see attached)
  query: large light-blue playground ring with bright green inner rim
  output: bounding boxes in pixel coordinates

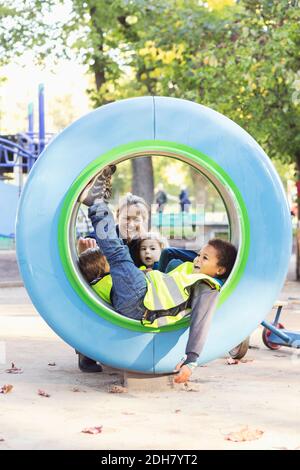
[17,97,292,374]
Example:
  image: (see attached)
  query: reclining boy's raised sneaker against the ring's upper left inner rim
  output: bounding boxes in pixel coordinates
[78,165,117,206]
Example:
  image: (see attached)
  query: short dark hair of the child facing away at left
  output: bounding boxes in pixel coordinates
[78,247,106,282]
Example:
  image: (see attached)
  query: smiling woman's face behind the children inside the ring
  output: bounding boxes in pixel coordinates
[118,204,148,241]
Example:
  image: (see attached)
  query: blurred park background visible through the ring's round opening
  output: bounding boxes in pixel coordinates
[76,155,229,251]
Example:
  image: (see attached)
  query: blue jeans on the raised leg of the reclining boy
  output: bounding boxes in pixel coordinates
[89,202,147,320]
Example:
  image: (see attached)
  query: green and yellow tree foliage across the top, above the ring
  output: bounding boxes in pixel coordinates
[0,0,300,170]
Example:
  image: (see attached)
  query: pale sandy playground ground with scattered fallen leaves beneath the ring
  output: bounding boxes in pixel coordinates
[0,258,300,450]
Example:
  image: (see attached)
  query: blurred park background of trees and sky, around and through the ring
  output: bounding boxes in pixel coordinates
[0,0,300,279]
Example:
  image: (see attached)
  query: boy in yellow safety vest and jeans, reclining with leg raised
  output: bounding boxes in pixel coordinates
[79,169,236,383]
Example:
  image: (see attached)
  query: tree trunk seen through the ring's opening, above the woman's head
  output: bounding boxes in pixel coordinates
[131,157,154,205]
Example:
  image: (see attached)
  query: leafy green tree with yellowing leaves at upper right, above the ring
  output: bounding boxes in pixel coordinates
[132,0,300,212]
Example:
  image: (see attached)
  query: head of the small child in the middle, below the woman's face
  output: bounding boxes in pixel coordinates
[138,232,168,270]
